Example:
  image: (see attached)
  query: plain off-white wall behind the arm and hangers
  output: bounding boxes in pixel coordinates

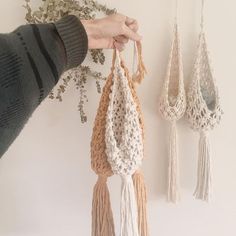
[0,0,236,236]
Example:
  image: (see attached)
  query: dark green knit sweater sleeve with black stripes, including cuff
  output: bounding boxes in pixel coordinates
[0,15,88,157]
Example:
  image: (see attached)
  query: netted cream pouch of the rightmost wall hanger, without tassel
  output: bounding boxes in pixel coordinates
[186,32,222,131]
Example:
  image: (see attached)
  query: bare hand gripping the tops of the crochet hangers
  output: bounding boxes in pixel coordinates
[81,14,141,51]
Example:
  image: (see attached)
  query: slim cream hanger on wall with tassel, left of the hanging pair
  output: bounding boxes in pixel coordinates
[159,0,186,203]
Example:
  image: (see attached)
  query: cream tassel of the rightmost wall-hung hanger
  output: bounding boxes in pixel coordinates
[194,131,212,201]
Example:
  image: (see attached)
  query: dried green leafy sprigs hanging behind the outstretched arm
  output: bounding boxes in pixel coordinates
[23,0,116,123]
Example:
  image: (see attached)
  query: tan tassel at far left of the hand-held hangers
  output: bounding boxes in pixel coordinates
[92,175,115,236]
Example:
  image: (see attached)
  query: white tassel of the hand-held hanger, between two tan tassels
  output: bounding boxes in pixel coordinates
[120,175,139,236]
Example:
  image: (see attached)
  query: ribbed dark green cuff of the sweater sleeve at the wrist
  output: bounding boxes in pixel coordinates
[55,15,88,69]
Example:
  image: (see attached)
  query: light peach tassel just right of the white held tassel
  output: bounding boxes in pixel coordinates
[132,171,149,236]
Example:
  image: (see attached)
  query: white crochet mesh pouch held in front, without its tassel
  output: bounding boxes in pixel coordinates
[105,55,143,176]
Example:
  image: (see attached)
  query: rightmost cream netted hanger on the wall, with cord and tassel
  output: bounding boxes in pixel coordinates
[186,0,223,201]
